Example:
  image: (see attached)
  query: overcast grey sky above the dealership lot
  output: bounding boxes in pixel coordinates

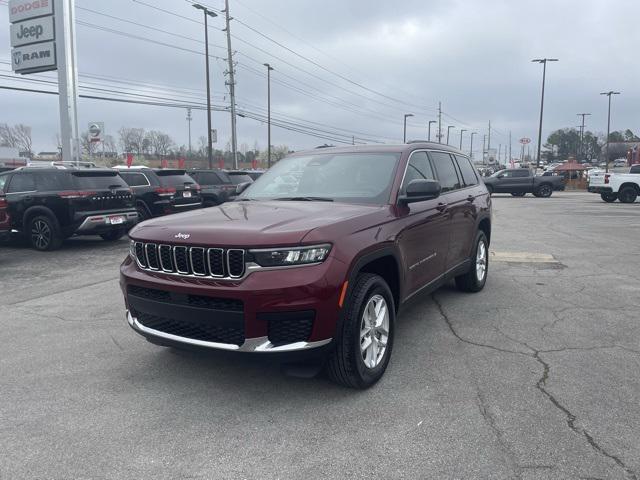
[0,0,640,155]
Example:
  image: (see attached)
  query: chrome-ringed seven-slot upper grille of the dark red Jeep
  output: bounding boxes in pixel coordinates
[134,242,245,278]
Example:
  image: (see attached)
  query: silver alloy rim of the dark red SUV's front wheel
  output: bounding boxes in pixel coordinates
[360,295,389,369]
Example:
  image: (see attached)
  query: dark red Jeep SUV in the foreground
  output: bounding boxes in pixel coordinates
[121,142,491,388]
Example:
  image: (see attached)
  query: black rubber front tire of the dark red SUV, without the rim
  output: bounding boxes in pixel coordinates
[326,273,396,389]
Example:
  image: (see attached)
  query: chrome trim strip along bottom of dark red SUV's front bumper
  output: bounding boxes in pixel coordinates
[127,310,333,353]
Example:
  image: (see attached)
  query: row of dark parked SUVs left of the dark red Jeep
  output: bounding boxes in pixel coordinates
[0,162,262,251]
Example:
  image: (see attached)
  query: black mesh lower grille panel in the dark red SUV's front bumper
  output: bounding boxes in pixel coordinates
[127,285,245,346]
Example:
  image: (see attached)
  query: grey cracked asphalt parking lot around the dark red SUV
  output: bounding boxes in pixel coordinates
[0,192,640,480]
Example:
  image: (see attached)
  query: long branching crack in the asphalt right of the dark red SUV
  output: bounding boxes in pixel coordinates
[431,294,638,480]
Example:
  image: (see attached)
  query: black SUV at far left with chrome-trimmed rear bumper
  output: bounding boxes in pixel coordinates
[0,167,138,250]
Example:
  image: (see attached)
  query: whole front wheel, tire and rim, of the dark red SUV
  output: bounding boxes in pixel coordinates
[326,273,395,389]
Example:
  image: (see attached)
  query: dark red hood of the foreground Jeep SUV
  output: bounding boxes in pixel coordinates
[130,201,388,247]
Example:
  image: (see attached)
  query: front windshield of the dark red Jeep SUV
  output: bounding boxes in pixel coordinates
[240,153,400,204]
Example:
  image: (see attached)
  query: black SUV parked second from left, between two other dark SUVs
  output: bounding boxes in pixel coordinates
[116,167,202,221]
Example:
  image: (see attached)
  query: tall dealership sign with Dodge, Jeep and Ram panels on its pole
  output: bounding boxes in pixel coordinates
[9,0,80,162]
